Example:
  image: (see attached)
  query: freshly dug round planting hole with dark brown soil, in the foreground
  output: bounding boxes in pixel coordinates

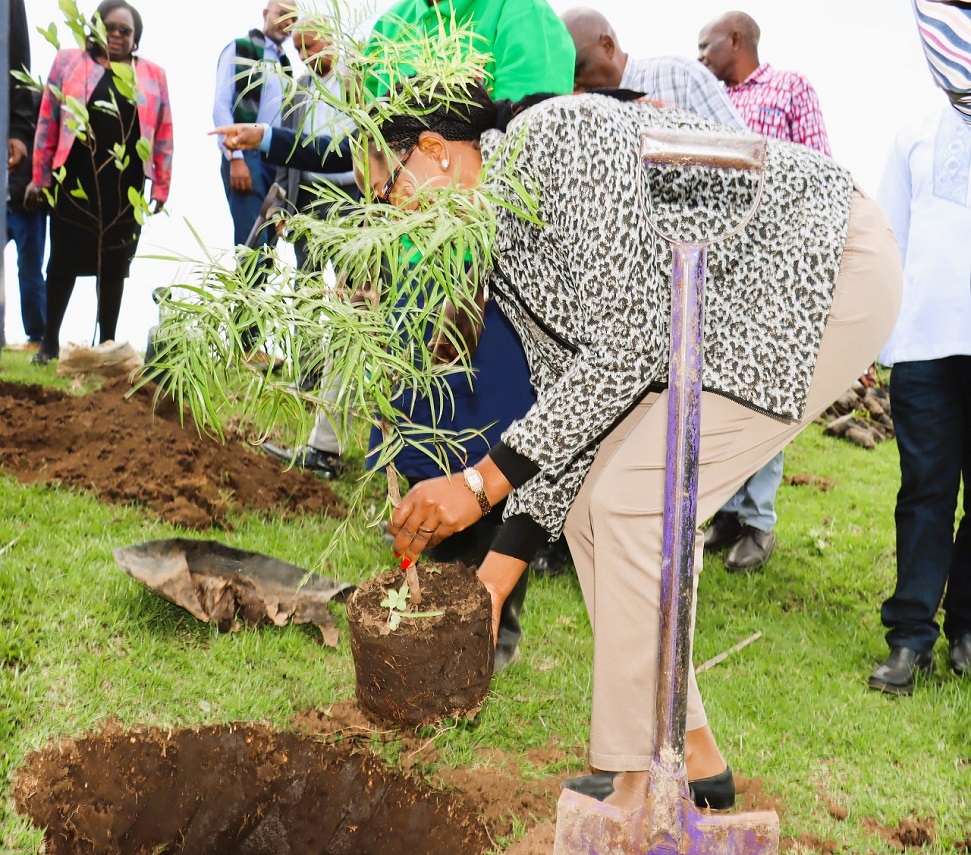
[14,724,488,855]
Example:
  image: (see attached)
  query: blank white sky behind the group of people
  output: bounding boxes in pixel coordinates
[5,0,944,350]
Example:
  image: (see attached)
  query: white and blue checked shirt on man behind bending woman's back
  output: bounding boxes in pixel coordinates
[620,56,747,128]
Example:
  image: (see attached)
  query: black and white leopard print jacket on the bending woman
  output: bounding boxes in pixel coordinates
[481,95,853,537]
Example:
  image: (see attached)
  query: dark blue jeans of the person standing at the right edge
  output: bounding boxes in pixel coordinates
[880,356,971,653]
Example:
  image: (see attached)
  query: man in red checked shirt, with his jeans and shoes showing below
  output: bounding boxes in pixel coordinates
[698,12,832,573]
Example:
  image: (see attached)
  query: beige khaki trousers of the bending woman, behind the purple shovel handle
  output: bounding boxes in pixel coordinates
[566,192,902,772]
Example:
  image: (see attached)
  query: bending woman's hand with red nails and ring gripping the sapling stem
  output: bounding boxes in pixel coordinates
[388,473,482,567]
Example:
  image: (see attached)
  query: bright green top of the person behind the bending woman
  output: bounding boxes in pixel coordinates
[370,0,576,101]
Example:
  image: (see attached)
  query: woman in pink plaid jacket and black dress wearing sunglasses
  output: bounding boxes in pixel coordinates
[27,0,172,364]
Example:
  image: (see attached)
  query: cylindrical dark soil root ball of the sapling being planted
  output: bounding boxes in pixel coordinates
[347,564,495,727]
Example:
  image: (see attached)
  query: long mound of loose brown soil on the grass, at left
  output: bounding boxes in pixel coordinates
[0,378,342,529]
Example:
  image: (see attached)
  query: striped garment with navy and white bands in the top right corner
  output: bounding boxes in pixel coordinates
[913,0,971,122]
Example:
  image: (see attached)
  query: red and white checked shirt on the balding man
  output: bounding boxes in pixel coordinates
[725,62,833,157]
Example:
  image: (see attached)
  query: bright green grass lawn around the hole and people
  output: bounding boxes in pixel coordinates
[0,353,971,853]
